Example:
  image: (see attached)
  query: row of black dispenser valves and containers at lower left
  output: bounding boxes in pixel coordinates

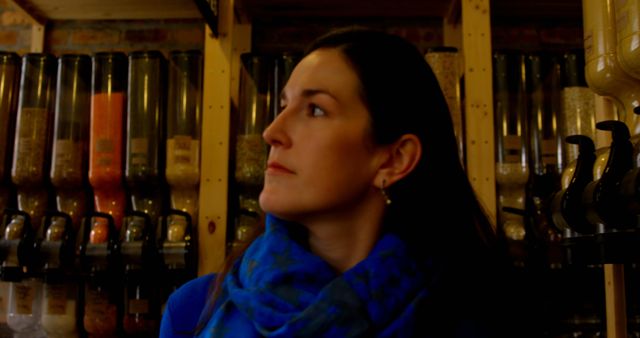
[0,210,197,337]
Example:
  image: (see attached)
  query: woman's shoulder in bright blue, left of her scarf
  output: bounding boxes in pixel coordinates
[160,274,215,337]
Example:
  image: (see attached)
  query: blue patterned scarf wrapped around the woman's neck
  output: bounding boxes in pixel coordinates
[199,215,428,337]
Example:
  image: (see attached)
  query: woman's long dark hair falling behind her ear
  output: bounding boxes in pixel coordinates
[195,27,510,336]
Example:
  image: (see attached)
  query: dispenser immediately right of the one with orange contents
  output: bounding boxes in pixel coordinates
[120,51,166,336]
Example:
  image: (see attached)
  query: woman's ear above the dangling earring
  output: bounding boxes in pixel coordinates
[374,134,422,188]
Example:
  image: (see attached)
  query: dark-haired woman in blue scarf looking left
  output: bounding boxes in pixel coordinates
[161,28,516,337]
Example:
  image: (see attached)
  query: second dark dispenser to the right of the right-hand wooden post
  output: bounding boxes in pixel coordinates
[525,53,562,268]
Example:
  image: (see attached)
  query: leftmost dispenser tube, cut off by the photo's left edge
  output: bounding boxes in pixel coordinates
[0,52,20,219]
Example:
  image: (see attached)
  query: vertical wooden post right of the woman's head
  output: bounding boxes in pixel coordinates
[462,0,496,220]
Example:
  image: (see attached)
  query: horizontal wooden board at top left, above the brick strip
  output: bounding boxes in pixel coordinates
[13,0,202,22]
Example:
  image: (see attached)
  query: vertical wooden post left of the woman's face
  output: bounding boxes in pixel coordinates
[198,0,235,275]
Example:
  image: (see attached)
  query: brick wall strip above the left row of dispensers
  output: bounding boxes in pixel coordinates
[0,0,204,55]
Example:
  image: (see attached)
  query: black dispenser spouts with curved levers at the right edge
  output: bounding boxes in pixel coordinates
[548,120,640,264]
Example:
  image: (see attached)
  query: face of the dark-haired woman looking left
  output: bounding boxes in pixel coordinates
[260,49,383,222]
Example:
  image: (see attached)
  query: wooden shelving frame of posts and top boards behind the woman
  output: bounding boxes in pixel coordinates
[9,0,625,338]
